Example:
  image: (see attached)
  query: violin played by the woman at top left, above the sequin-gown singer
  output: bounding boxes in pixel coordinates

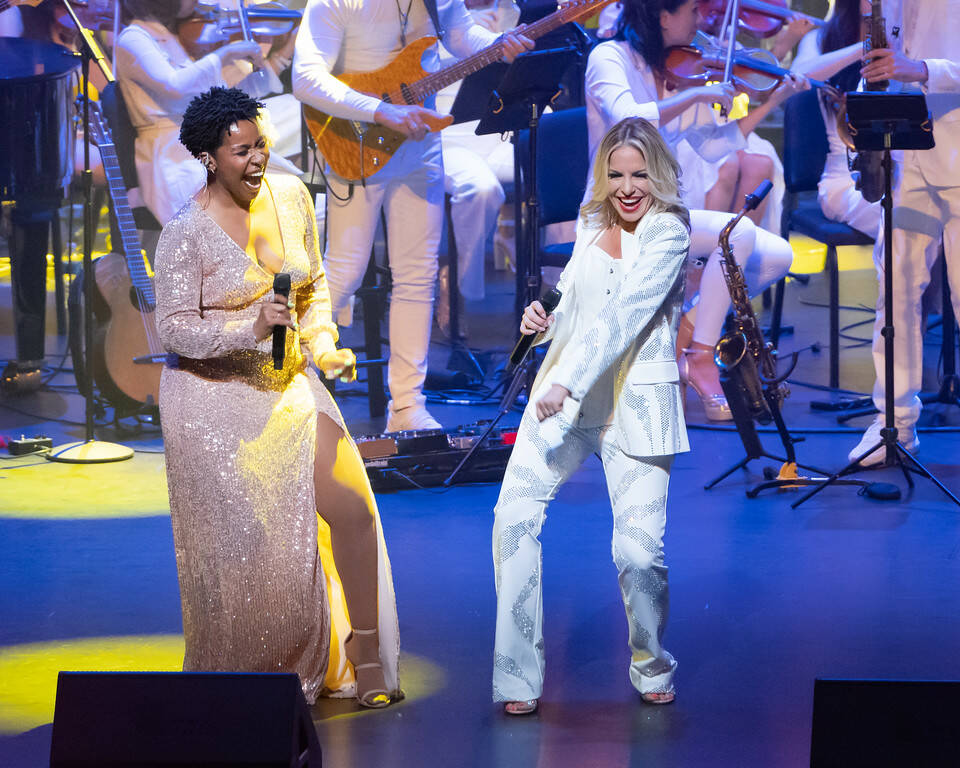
[177,2,303,59]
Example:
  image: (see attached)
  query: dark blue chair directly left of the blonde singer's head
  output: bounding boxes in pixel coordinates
[517,107,590,293]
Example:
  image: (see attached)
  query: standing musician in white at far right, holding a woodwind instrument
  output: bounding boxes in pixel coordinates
[850,0,960,465]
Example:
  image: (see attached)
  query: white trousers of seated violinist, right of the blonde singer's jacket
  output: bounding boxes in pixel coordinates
[687,210,793,345]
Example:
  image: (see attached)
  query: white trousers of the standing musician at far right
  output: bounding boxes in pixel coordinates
[873,152,960,424]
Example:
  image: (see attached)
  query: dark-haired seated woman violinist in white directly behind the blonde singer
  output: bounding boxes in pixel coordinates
[586,0,808,421]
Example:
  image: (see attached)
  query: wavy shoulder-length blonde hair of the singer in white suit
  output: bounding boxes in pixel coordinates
[580,117,690,229]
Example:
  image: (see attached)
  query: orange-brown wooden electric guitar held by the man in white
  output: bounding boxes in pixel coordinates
[303,0,613,181]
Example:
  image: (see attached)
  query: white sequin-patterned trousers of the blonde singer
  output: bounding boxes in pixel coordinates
[493,408,677,701]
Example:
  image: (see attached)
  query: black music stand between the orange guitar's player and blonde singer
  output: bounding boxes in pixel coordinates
[443,48,580,486]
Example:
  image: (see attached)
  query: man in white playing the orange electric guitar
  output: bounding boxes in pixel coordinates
[293,0,533,431]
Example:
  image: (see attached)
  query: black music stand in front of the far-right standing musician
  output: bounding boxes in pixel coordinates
[790,92,960,509]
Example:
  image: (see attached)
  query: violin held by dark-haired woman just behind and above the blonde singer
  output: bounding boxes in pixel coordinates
[663,40,839,100]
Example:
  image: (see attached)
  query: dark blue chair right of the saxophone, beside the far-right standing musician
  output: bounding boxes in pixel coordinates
[771,89,874,389]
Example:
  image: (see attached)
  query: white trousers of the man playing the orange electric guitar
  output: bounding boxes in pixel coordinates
[323,134,443,410]
